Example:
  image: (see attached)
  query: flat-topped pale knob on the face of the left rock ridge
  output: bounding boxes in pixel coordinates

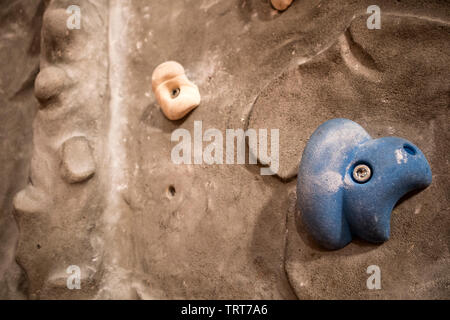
[61,136,95,183]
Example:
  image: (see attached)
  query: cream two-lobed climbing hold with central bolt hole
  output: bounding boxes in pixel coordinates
[152,61,201,120]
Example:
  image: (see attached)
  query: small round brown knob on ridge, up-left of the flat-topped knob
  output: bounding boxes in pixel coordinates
[34,67,67,102]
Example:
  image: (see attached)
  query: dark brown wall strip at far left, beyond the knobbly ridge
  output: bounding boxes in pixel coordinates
[0,0,44,299]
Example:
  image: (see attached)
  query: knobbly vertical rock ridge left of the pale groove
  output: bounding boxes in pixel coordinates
[14,1,109,299]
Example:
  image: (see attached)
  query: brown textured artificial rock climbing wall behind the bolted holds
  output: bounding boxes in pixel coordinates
[0,0,450,299]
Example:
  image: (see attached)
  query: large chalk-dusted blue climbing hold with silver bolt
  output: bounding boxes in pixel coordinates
[297,119,431,249]
